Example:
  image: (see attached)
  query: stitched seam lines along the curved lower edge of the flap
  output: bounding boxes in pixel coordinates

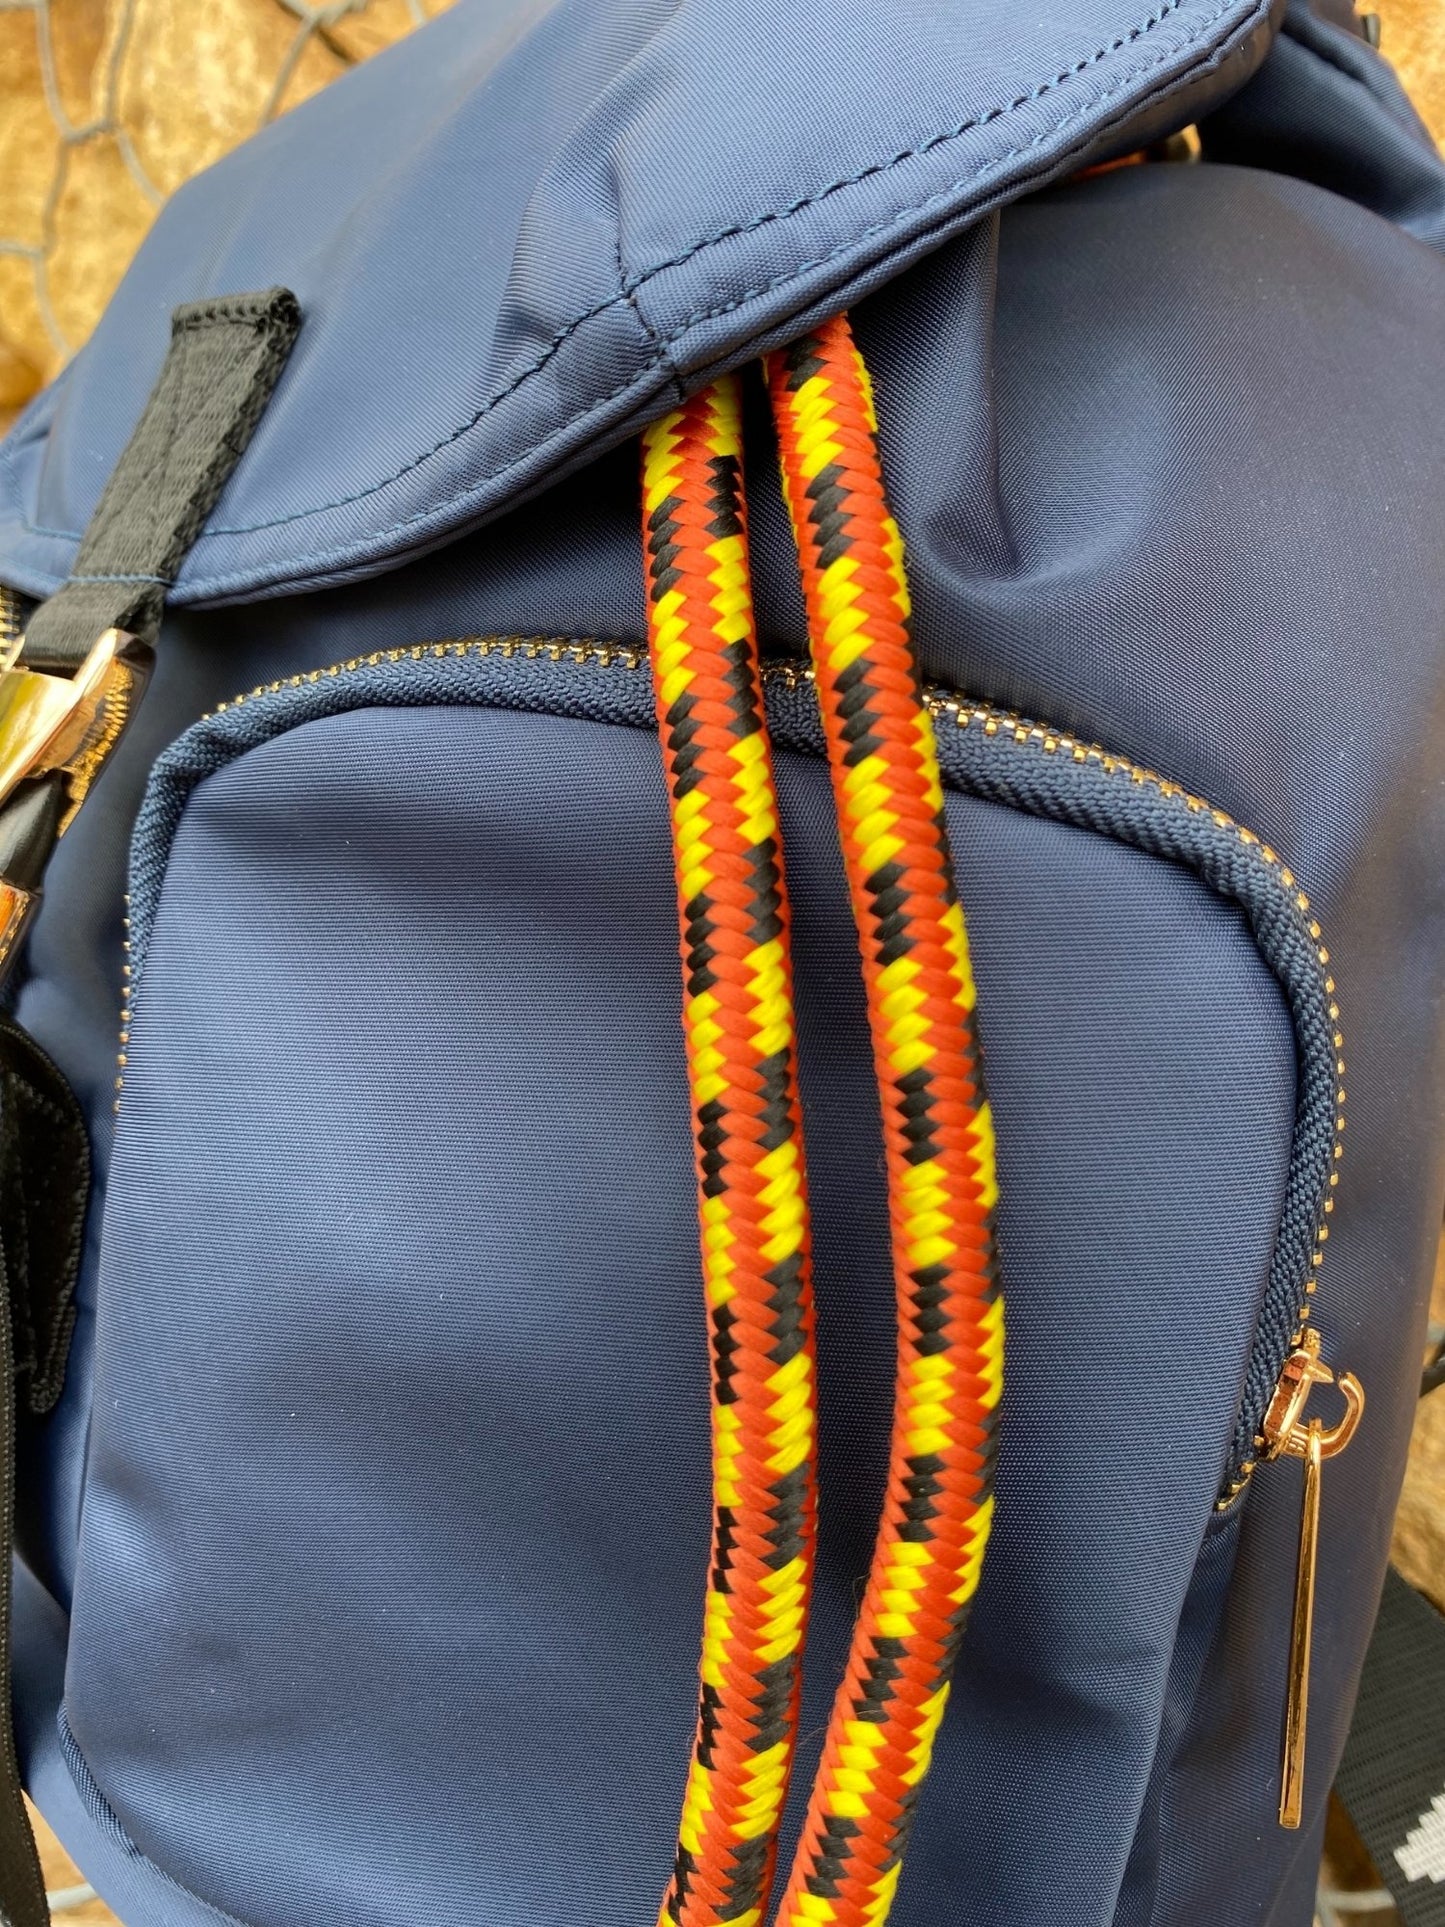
[8,0,1270,558]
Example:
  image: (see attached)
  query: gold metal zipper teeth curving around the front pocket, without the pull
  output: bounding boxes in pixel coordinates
[118,635,1345,1511]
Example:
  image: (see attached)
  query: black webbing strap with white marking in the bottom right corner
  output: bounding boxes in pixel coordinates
[1335,1567,1445,1927]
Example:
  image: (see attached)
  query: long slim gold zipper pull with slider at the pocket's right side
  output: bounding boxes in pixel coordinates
[1260,1330,1364,1827]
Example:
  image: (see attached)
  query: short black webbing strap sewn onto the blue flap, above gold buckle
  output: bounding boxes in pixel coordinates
[23,287,301,669]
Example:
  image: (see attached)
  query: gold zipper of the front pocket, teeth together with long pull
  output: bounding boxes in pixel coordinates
[116,635,1364,1827]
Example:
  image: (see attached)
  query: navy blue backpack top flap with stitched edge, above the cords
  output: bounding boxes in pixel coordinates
[0,0,1279,601]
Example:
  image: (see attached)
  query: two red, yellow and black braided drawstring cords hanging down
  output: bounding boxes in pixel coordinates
[644,318,1004,1927]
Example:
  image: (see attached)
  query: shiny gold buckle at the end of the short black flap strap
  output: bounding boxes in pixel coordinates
[0,628,150,831]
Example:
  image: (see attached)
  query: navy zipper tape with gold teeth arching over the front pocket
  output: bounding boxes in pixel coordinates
[118,636,1345,1507]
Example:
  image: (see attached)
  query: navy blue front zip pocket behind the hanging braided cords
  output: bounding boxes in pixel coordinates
[64,638,1337,1927]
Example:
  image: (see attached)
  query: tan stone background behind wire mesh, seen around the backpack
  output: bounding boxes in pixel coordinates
[0,0,1445,1927]
